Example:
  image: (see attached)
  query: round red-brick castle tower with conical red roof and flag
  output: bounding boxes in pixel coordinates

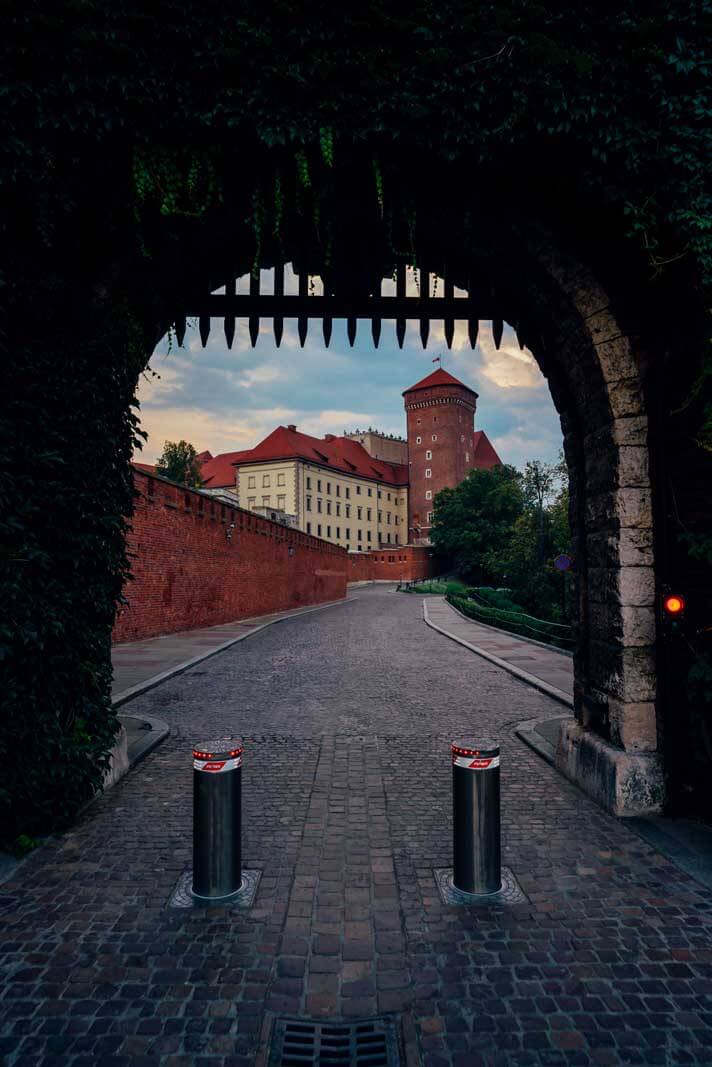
[404,367,482,544]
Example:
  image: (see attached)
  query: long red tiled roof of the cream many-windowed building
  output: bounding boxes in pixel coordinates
[213,426,408,488]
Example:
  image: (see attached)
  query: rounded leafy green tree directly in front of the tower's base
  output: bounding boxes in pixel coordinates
[430,464,523,582]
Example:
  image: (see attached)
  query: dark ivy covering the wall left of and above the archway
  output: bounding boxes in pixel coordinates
[0,0,712,839]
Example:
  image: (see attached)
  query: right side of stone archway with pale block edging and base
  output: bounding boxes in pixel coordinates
[138,203,665,815]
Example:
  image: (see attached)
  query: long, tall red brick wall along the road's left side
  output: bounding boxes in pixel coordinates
[113,471,347,642]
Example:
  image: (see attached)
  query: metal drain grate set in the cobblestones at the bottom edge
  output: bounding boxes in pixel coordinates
[269,1019,400,1067]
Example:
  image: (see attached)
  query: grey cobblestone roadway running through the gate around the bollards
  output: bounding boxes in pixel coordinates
[0,587,712,1067]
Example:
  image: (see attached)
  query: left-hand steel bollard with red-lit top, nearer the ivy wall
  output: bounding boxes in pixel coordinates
[192,737,242,901]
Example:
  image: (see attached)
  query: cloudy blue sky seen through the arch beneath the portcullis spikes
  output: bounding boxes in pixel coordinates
[137,262,561,466]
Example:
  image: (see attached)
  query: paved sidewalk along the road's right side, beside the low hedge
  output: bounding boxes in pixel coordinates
[423,596,573,707]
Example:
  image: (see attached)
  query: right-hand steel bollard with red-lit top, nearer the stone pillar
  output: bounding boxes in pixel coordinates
[453,740,502,895]
